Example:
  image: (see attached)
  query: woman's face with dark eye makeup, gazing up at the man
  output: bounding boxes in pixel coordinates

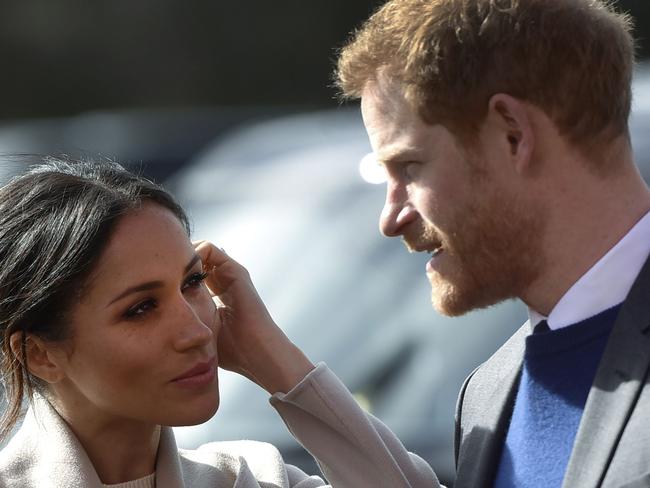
[48,203,220,425]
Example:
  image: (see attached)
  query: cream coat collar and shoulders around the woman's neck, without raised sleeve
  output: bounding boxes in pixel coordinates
[0,394,268,488]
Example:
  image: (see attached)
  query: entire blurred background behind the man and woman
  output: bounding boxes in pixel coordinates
[0,0,650,485]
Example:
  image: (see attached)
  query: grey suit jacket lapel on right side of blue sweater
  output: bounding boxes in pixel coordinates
[562,255,650,488]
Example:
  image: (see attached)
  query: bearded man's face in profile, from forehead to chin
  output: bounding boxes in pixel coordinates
[361,81,543,316]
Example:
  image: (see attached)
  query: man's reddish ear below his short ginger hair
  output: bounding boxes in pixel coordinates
[487,93,535,174]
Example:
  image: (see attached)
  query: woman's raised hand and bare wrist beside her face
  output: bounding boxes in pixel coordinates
[194,241,314,394]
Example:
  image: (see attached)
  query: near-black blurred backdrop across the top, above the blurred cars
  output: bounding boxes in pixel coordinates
[0,0,650,119]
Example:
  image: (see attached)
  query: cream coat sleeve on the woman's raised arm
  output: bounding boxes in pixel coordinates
[270,363,444,488]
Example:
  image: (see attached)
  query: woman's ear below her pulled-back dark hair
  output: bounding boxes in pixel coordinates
[9,331,65,383]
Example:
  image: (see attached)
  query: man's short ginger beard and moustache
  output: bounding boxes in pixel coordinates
[404,179,544,316]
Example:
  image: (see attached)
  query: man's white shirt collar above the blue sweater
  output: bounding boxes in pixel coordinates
[528,212,650,330]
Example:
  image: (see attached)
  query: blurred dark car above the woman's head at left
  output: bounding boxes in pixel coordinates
[0,106,295,184]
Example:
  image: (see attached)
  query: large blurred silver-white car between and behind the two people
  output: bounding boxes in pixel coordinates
[170,66,650,484]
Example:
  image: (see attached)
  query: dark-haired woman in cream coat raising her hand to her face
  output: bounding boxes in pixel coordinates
[0,160,438,488]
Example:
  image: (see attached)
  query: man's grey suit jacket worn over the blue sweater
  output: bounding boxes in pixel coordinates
[454,258,650,488]
